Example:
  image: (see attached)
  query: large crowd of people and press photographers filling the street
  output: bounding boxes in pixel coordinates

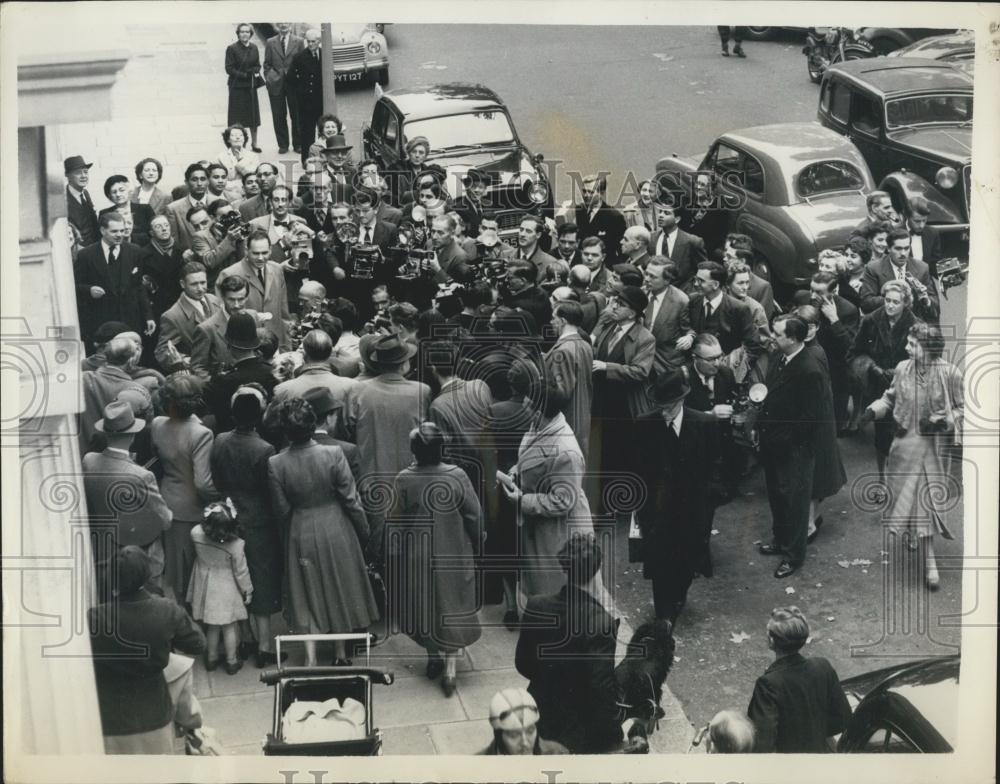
[65,25,963,753]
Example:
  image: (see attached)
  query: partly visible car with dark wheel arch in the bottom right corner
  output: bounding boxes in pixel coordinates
[837,654,961,754]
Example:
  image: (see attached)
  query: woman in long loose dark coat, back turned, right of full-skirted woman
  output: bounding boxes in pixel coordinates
[389,422,483,697]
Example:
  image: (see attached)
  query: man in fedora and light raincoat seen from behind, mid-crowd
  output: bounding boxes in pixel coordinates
[345,334,431,560]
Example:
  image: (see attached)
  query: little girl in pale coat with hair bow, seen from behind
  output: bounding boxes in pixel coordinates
[187,498,253,675]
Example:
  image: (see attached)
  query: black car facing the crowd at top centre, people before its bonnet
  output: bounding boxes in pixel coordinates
[361,84,552,244]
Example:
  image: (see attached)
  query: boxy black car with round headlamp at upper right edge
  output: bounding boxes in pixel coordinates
[819,57,972,259]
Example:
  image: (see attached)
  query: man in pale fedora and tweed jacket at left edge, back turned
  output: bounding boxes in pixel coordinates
[83,400,173,587]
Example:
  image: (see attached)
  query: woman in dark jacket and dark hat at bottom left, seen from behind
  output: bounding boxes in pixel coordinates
[87,546,205,754]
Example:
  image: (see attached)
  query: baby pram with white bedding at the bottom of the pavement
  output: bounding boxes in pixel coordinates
[260,634,395,757]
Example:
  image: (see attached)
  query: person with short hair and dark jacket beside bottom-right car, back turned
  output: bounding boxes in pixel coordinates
[747,607,851,754]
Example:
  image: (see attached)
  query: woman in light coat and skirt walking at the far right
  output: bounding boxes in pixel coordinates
[862,322,965,591]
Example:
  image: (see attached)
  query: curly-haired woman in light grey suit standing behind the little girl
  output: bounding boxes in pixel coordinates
[151,373,219,602]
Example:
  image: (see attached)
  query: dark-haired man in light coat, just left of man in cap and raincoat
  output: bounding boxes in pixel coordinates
[544,300,594,455]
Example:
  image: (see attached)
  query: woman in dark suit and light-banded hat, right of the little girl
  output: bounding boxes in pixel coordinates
[210,384,283,667]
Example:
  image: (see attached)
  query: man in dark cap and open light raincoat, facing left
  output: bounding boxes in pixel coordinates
[587,286,656,512]
